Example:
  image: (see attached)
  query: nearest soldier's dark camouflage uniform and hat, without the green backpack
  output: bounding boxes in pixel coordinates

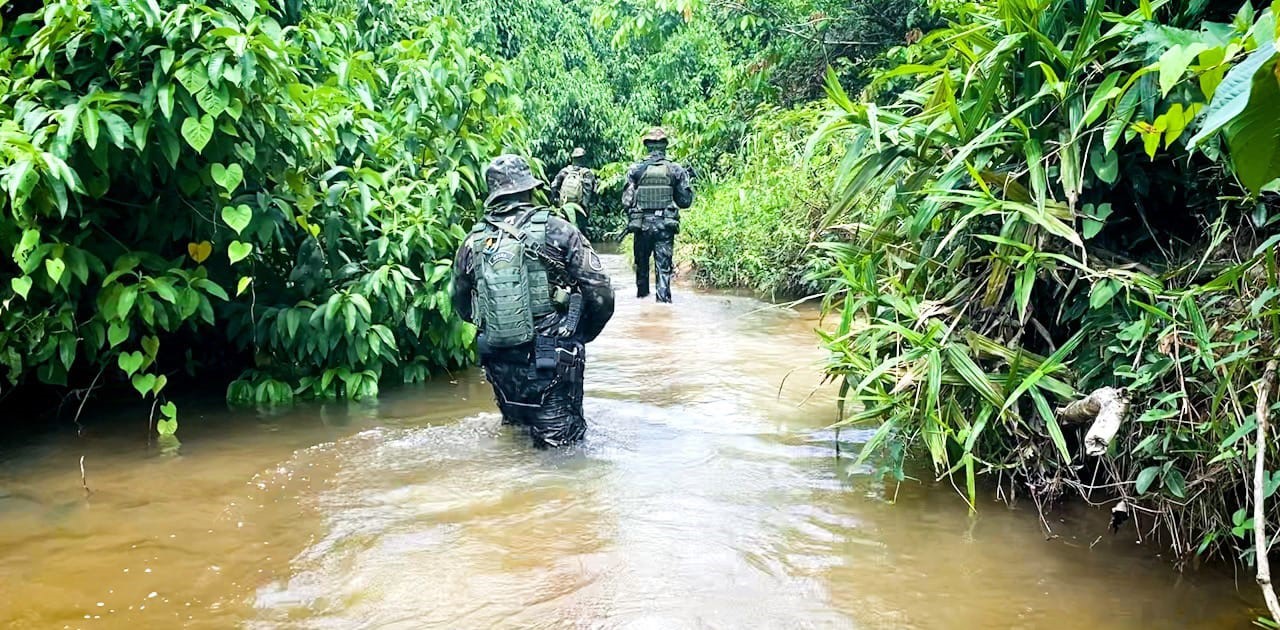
[453,156,613,447]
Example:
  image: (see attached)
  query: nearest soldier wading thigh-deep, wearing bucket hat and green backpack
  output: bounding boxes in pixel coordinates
[453,155,613,447]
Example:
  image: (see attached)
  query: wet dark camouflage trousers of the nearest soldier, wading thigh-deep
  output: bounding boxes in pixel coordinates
[484,339,586,447]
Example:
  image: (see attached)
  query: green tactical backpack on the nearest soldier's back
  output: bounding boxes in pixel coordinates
[467,209,556,348]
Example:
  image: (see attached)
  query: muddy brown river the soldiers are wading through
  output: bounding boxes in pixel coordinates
[0,256,1257,629]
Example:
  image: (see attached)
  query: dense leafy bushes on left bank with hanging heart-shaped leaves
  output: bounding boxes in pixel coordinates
[0,0,522,422]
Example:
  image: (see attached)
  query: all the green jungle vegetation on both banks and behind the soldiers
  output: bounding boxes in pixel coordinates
[0,0,1280,601]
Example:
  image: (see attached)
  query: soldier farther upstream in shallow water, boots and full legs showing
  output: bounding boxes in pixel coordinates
[622,127,694,302]
